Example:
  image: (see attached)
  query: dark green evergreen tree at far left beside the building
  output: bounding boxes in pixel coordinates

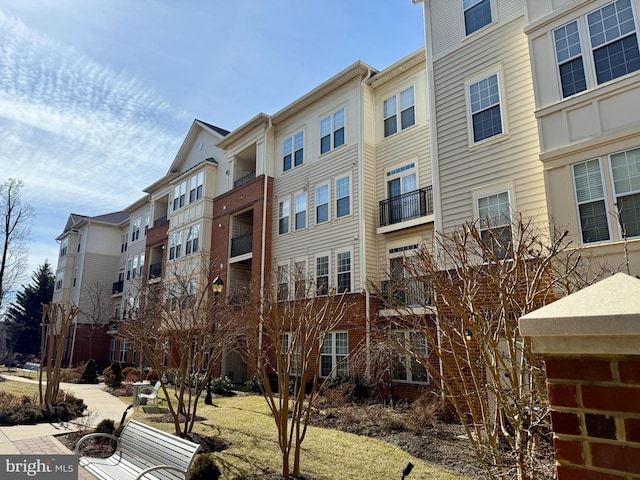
[7,260,55,356]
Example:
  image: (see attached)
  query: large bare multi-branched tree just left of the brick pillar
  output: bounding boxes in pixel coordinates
[372,215,608,480]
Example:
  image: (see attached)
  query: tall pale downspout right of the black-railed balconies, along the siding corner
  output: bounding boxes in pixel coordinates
[412,0,445,403]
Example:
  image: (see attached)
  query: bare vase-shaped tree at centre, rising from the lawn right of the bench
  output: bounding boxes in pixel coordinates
[249,272,348,478]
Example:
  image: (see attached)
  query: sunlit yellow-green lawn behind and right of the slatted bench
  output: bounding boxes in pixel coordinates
[135,395,467,480]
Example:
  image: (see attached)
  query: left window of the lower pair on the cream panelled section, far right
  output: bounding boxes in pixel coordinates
[572,158,611,243]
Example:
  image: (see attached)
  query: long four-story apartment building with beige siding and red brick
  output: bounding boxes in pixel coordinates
[54,0,640,395]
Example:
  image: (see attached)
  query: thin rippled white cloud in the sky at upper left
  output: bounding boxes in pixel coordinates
[0,11,192,280]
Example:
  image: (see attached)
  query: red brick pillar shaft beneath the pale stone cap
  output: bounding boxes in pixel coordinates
[545,355,640,480]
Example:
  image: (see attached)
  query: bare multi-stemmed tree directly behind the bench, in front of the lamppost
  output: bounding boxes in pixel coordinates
[119,253,229,437]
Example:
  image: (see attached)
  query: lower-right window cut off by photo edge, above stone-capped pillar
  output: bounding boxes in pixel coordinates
[611,148,640,238]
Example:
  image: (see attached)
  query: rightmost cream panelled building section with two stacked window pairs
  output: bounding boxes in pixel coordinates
[525,0,640,276]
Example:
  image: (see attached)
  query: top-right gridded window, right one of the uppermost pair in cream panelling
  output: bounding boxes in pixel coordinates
[587,0,640,84]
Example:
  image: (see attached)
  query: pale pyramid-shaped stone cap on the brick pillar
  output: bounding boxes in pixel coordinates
[519,273,640,355]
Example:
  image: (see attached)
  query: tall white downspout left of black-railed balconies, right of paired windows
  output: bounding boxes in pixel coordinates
[358,68,373,378]
